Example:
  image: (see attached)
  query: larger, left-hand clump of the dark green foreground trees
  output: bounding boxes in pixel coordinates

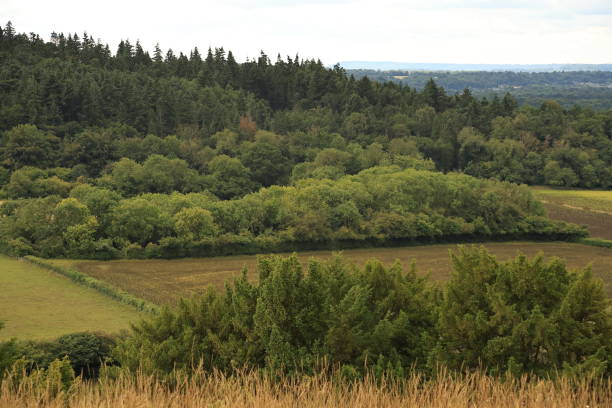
[115,256,434,373]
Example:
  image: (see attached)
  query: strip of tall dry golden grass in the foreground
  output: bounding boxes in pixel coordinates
[0,371,612,408]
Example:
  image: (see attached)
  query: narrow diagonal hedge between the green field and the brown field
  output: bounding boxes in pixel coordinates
[21,255,160,314]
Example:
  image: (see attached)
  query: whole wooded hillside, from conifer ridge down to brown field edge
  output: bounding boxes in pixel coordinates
[0,23,612,258]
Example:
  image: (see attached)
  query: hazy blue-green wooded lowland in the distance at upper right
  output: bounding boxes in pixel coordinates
[347,67,612,110]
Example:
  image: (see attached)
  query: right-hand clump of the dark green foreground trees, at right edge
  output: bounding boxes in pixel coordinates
[437,248,612,375]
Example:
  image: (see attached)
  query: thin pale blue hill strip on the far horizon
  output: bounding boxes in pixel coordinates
[339,61,612,72]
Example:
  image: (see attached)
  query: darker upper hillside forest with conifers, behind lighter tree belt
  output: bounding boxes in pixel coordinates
[0,23,612,192]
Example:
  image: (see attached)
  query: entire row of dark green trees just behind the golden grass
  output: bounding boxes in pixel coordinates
[115,247,612,378]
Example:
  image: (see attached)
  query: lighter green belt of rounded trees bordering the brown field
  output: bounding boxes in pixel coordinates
[0,168,586,258]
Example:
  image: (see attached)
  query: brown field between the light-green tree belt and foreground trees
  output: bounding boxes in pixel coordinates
[54,242,612,304]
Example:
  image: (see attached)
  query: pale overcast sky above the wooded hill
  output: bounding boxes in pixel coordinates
[0,0,612,65]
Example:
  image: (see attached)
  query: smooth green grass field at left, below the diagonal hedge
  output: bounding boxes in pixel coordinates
[0,255,142,340]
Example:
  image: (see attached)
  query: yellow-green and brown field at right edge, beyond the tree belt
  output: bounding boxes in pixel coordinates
[533,187,612,240]
